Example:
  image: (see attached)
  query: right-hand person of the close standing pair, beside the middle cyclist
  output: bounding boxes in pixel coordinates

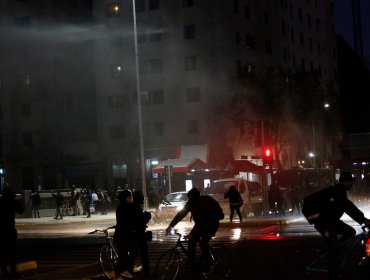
[133,191,151,278]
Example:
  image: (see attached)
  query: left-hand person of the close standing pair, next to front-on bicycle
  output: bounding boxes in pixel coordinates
[113,189,137,280]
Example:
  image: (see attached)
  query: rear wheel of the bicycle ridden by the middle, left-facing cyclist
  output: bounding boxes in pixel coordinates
[203,244,233,280]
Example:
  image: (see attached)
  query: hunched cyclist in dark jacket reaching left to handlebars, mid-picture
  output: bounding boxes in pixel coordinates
[166,188,224,266]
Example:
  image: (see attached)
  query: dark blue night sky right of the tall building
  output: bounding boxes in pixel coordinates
[335,0,370,63]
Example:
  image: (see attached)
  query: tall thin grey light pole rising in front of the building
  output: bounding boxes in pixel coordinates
[132,0,148,209]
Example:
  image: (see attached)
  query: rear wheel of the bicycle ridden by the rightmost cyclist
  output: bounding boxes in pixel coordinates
[285,247,328,280]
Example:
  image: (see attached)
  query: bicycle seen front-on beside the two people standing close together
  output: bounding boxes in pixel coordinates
[89,226,118,279]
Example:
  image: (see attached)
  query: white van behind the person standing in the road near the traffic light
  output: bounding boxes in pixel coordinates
[205,178,262,217]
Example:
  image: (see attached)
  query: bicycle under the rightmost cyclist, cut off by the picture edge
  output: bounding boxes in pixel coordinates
[285,226,370,280]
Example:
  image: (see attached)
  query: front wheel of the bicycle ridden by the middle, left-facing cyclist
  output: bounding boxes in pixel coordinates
[155,249,181,280]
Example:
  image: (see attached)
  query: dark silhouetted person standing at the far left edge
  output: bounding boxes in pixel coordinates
[0,187,24,279]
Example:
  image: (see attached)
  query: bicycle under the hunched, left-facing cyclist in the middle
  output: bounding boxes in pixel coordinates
[155,230,232,280]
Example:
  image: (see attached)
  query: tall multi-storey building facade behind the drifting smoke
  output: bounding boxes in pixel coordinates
[0,0,337,191]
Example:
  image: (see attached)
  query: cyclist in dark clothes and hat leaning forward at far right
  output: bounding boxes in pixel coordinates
[314,172,370,280]
